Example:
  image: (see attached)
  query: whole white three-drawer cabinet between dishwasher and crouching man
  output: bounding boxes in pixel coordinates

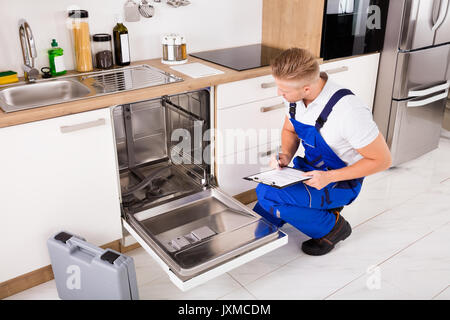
[216,75,285,195]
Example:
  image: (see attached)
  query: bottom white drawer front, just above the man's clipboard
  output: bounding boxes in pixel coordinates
[217,140,281,196]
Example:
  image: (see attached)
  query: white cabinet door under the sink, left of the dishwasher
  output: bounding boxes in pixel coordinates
[0,109,121,282]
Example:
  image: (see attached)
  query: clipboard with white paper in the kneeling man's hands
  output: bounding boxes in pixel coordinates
[243,167,311,189]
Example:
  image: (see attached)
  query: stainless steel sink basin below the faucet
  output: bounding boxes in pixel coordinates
[0,79,91,112]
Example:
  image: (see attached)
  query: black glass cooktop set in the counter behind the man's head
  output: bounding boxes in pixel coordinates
[190,44,283,71]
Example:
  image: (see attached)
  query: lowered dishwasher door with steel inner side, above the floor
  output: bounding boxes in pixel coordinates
[123,189,288,291]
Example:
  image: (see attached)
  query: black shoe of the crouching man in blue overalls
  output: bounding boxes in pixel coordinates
[302,210,352,256]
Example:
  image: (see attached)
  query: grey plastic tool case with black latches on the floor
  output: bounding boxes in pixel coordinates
[47,232,139,300]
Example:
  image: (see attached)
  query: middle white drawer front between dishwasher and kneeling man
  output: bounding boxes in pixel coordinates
[216,97,286,157]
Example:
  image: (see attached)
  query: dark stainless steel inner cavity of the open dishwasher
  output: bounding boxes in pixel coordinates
[113,90,210,213]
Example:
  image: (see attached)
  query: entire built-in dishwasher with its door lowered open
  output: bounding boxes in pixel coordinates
[112,88,288,291]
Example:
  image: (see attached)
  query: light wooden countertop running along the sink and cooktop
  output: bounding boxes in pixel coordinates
[0,56,270,128]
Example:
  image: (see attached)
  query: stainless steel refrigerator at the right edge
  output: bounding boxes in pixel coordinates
[373,0,450,166]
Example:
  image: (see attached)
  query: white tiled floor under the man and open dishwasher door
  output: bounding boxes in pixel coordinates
[8,133,450,300]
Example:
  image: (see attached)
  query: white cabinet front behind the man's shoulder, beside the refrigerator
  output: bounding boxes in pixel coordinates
[320,53,380,110]
